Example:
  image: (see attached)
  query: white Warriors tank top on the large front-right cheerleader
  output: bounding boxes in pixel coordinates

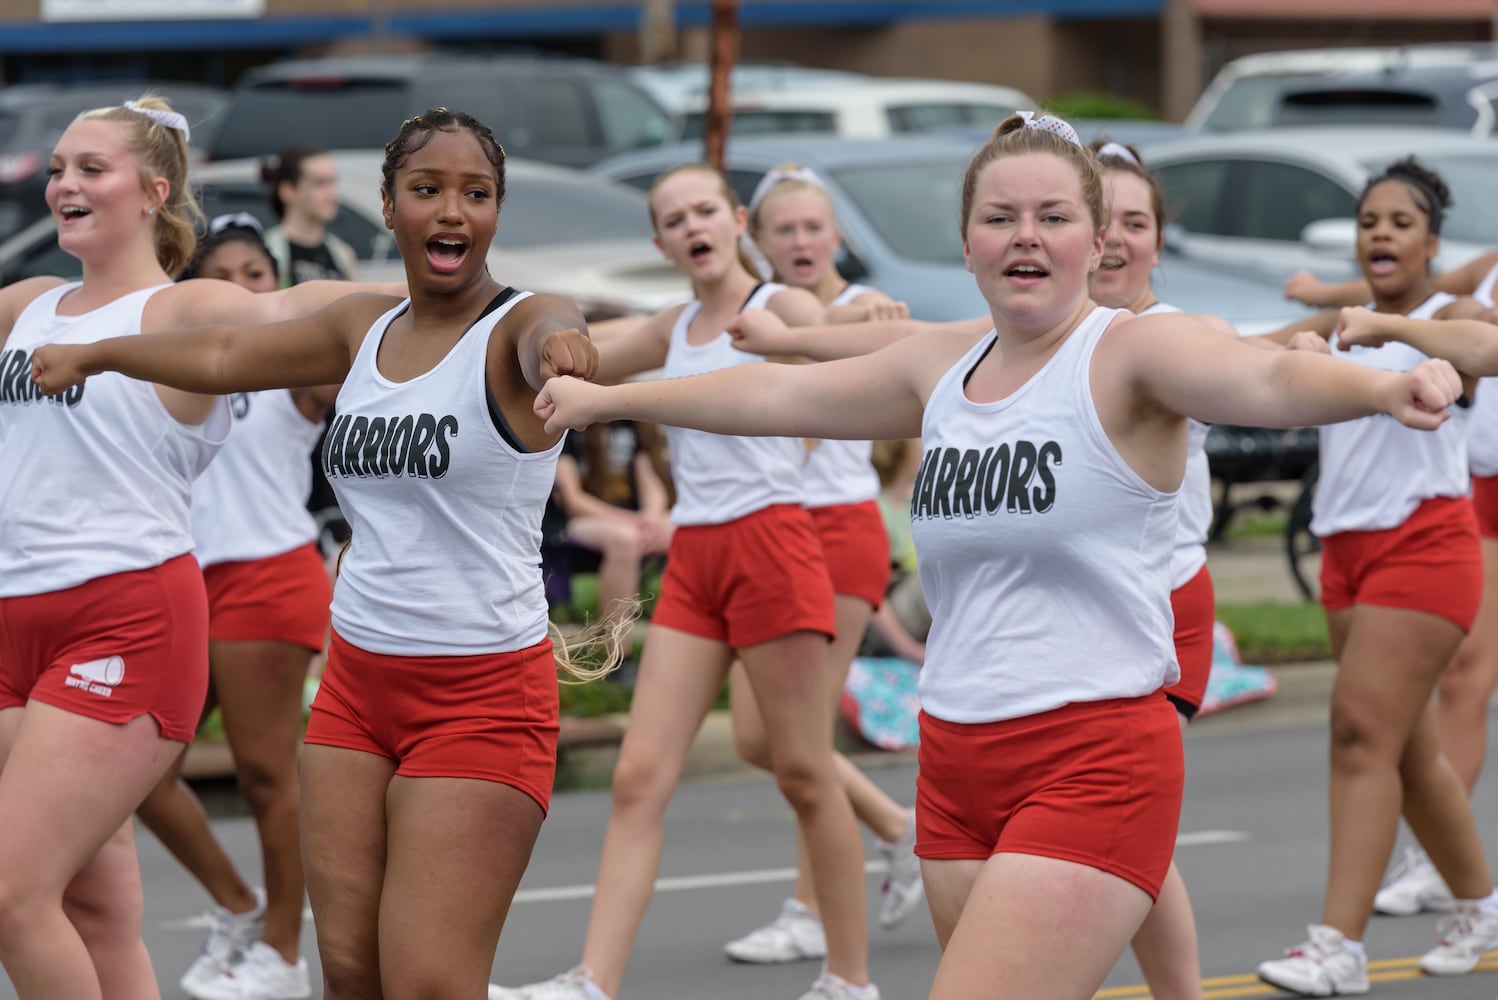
[911,308,1180,723]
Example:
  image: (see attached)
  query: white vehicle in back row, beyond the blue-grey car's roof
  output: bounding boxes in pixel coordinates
[682,76,1037,139]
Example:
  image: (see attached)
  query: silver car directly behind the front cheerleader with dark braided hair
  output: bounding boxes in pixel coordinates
[0,151,691,316]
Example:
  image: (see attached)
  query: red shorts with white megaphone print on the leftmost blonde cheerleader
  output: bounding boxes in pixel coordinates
[0,555,208,743]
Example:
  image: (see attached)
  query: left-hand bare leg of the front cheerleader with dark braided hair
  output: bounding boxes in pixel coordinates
[301,744,395,1000]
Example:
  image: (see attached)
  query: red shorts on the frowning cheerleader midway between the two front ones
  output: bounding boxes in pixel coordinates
[650,503,837,650]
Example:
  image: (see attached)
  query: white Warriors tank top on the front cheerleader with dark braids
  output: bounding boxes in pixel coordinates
[322,293,562,656]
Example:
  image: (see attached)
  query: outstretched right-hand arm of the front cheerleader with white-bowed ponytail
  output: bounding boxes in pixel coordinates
[1112,316,1462,430]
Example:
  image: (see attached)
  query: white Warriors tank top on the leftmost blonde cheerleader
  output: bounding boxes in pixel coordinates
[0,283,229,597]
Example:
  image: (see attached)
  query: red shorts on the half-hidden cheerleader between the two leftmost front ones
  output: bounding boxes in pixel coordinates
[202,542,333,651]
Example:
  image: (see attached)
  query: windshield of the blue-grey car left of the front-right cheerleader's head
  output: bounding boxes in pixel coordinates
[831,159,968,263]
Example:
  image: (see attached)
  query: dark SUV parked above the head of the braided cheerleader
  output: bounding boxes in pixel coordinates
[210,52,673,168]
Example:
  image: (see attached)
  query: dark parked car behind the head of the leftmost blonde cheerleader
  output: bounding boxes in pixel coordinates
[0,81,228,240]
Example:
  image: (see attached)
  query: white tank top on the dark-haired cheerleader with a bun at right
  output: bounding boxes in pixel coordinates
[1311,292,1470,537]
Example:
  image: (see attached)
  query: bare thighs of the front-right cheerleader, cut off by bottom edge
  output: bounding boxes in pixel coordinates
[924,853,1150,1000]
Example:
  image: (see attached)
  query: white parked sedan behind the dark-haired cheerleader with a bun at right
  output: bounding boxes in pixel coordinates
[1144,127,1498,281]
